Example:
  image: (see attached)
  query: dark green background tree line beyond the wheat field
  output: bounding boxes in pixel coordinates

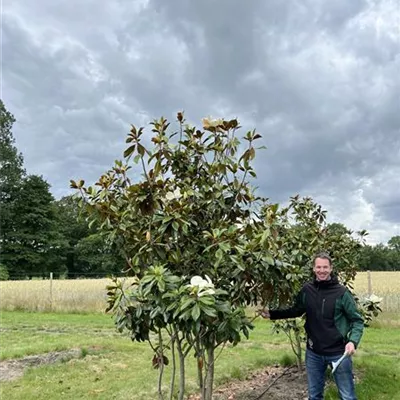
[0,100,400,279]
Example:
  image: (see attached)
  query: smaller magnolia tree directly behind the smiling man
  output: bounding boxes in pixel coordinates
[264,196,381,369]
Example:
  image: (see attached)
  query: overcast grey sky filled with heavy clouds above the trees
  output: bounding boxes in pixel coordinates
[1,0,400,243]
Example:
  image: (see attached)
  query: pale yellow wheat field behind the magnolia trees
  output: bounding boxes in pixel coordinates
[0,271,400,313]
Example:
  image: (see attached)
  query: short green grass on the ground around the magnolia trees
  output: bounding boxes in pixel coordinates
[0,312,400,400]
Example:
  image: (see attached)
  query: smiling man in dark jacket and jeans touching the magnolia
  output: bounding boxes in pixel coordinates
[261,253,364,400]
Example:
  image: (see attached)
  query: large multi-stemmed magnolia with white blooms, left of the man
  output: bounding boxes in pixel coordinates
[71,113,304,399]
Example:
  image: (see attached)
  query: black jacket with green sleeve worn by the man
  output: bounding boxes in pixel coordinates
[270,276,364,355]
